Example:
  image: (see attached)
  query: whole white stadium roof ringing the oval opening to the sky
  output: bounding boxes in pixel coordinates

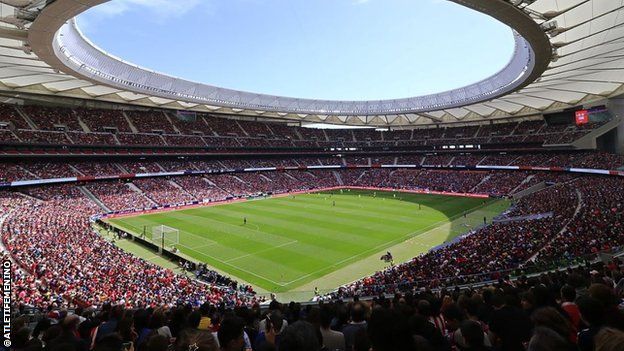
[0,0,624,126]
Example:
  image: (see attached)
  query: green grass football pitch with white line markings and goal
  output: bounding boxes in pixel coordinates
[106,189,508,292]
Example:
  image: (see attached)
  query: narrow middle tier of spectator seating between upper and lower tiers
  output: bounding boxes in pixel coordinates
[0,152,624,182]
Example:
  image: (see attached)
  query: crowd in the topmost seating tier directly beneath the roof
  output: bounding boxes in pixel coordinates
[0,104,601,149]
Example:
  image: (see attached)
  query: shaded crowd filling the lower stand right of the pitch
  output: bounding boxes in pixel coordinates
[336,177,624,297]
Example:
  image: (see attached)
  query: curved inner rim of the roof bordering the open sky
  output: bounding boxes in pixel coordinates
[29,0,552,120]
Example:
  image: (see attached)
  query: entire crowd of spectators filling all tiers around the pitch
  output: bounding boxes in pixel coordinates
[0,105,624,340]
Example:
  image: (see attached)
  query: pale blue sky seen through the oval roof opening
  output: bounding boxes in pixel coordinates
[78,0,513,100]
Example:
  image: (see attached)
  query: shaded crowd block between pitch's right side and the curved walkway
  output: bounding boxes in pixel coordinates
[335,218,561,297]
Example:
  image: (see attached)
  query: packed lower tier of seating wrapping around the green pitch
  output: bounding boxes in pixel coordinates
[0,169,624,307]
